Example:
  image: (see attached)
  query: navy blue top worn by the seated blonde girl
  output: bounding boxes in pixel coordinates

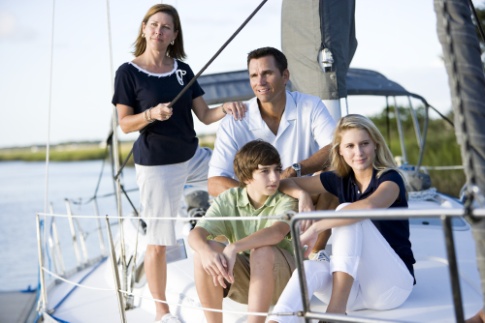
[320,169,416,284]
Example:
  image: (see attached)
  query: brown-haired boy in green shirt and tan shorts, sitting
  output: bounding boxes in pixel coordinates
[189,140,298,323]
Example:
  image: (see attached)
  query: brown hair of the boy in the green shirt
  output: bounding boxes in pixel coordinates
[234,139,281,187]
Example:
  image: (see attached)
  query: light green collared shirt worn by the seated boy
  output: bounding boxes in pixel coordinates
[197,187,298,253]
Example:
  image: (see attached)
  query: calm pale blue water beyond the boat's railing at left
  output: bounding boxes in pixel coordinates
[0,161,138,291]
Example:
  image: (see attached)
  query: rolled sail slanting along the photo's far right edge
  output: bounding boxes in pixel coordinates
[434,0,485,308]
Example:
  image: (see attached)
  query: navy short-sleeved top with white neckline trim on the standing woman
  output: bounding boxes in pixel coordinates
[112,60,204,166]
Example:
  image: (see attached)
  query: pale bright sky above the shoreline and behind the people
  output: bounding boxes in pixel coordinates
[0,0,479,148]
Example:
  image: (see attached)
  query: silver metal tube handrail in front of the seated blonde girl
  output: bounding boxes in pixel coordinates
[290,208,485,322]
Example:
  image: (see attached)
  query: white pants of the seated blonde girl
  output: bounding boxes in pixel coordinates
[269,205,414,323]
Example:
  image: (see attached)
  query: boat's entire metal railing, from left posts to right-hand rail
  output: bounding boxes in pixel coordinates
[37,201,485,323]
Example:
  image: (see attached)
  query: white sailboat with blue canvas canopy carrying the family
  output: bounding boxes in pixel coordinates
[32,0,483,322]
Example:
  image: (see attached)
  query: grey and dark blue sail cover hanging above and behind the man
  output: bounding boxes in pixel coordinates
[281,0,357,100]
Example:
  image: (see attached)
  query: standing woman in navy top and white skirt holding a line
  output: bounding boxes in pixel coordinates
[112,4,245,322]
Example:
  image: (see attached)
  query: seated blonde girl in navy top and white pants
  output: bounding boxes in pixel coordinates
[271,114,415,322]
